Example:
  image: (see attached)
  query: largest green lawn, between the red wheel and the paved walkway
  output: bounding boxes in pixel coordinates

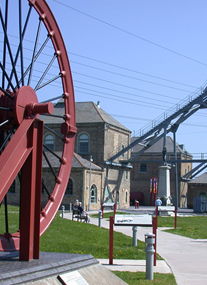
[40,212,157,259]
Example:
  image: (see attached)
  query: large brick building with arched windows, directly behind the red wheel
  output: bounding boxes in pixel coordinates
[7,100,131,210]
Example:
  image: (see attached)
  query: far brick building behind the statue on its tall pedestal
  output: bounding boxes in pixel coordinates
[130,136,192,207]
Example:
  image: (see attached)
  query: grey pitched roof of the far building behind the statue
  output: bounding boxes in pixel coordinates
[131,136,189,154]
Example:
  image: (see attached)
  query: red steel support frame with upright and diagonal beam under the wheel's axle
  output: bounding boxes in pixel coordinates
[0,116,43,261]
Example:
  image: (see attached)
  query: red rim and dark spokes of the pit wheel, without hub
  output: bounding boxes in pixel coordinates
[0,0,76,251]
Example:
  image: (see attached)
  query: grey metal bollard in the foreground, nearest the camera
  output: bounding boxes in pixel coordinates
[145,233,155,280]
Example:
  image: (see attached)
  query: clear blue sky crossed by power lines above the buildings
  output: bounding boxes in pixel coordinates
[0,0,207,158]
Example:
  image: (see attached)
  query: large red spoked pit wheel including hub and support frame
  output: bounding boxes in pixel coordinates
[0,0,76,260]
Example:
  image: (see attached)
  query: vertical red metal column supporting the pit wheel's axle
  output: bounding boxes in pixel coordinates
[19,118,43,261]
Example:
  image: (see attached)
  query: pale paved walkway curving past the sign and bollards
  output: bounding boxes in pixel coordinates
[65,206,207,285]
